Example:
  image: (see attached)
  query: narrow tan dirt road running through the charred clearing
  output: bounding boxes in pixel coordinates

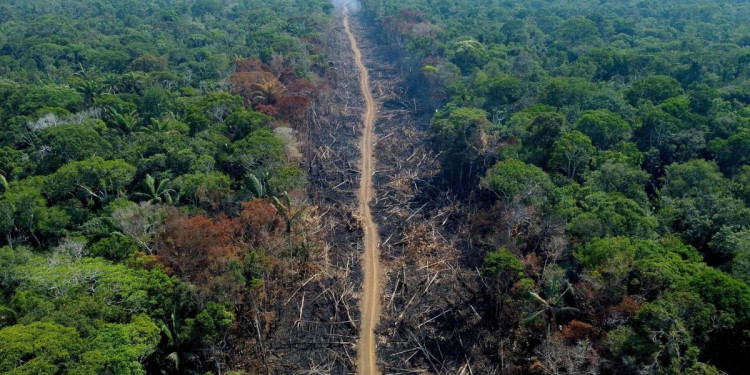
[344,10,380,375]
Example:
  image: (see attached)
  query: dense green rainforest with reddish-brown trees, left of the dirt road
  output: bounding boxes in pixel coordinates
[0,0,333,374]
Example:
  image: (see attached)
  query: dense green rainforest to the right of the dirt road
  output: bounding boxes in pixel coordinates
[364,0,750,374]
